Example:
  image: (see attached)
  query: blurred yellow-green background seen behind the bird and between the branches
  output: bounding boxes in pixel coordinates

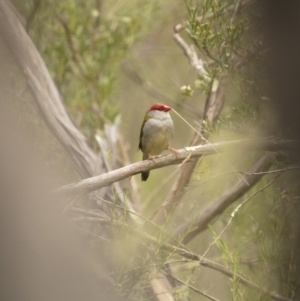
[8,0,297,300]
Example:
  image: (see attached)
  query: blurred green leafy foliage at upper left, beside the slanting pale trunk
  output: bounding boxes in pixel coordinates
[13,0,158,142]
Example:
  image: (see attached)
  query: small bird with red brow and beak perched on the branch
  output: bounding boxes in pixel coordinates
[139,104,178,181]
